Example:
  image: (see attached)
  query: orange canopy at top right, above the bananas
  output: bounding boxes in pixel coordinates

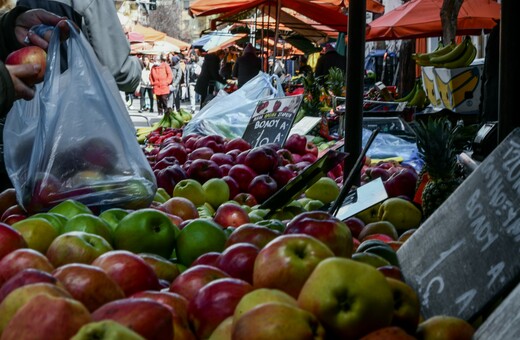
[366,0,500,41]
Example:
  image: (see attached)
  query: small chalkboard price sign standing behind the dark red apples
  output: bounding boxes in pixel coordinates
[242,95,303,147]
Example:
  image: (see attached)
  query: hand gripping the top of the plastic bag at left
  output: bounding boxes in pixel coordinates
[14,9,69,50]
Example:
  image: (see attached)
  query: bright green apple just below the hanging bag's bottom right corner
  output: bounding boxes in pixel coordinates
[113,208,179,258]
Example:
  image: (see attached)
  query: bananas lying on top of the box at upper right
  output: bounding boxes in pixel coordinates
[412,36,477,69]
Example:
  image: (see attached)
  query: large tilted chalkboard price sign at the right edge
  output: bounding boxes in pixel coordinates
[397,128,520,321]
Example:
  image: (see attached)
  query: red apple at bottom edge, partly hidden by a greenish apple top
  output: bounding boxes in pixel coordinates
[92,297,173,340]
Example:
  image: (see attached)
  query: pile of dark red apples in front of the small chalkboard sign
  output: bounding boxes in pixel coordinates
[145,132,343,203]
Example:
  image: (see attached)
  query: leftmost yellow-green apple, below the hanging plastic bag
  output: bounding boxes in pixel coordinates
[12,218,60,254]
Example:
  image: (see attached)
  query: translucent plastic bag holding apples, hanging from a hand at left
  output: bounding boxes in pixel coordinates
[4,23,157,212]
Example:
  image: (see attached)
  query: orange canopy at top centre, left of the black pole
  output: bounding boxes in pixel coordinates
[189,0,348,32]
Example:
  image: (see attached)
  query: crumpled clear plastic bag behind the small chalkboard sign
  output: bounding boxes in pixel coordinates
[183,72,285,138]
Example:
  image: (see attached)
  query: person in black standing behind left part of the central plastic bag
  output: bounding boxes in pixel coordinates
[195,50,226,109]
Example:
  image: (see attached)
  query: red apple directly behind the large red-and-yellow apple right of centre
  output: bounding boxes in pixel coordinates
[284,211,353,257]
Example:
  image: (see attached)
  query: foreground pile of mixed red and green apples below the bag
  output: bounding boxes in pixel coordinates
[0,182,474,339]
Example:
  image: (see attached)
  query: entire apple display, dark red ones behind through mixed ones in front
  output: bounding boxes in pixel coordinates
[0,123,488,340]
